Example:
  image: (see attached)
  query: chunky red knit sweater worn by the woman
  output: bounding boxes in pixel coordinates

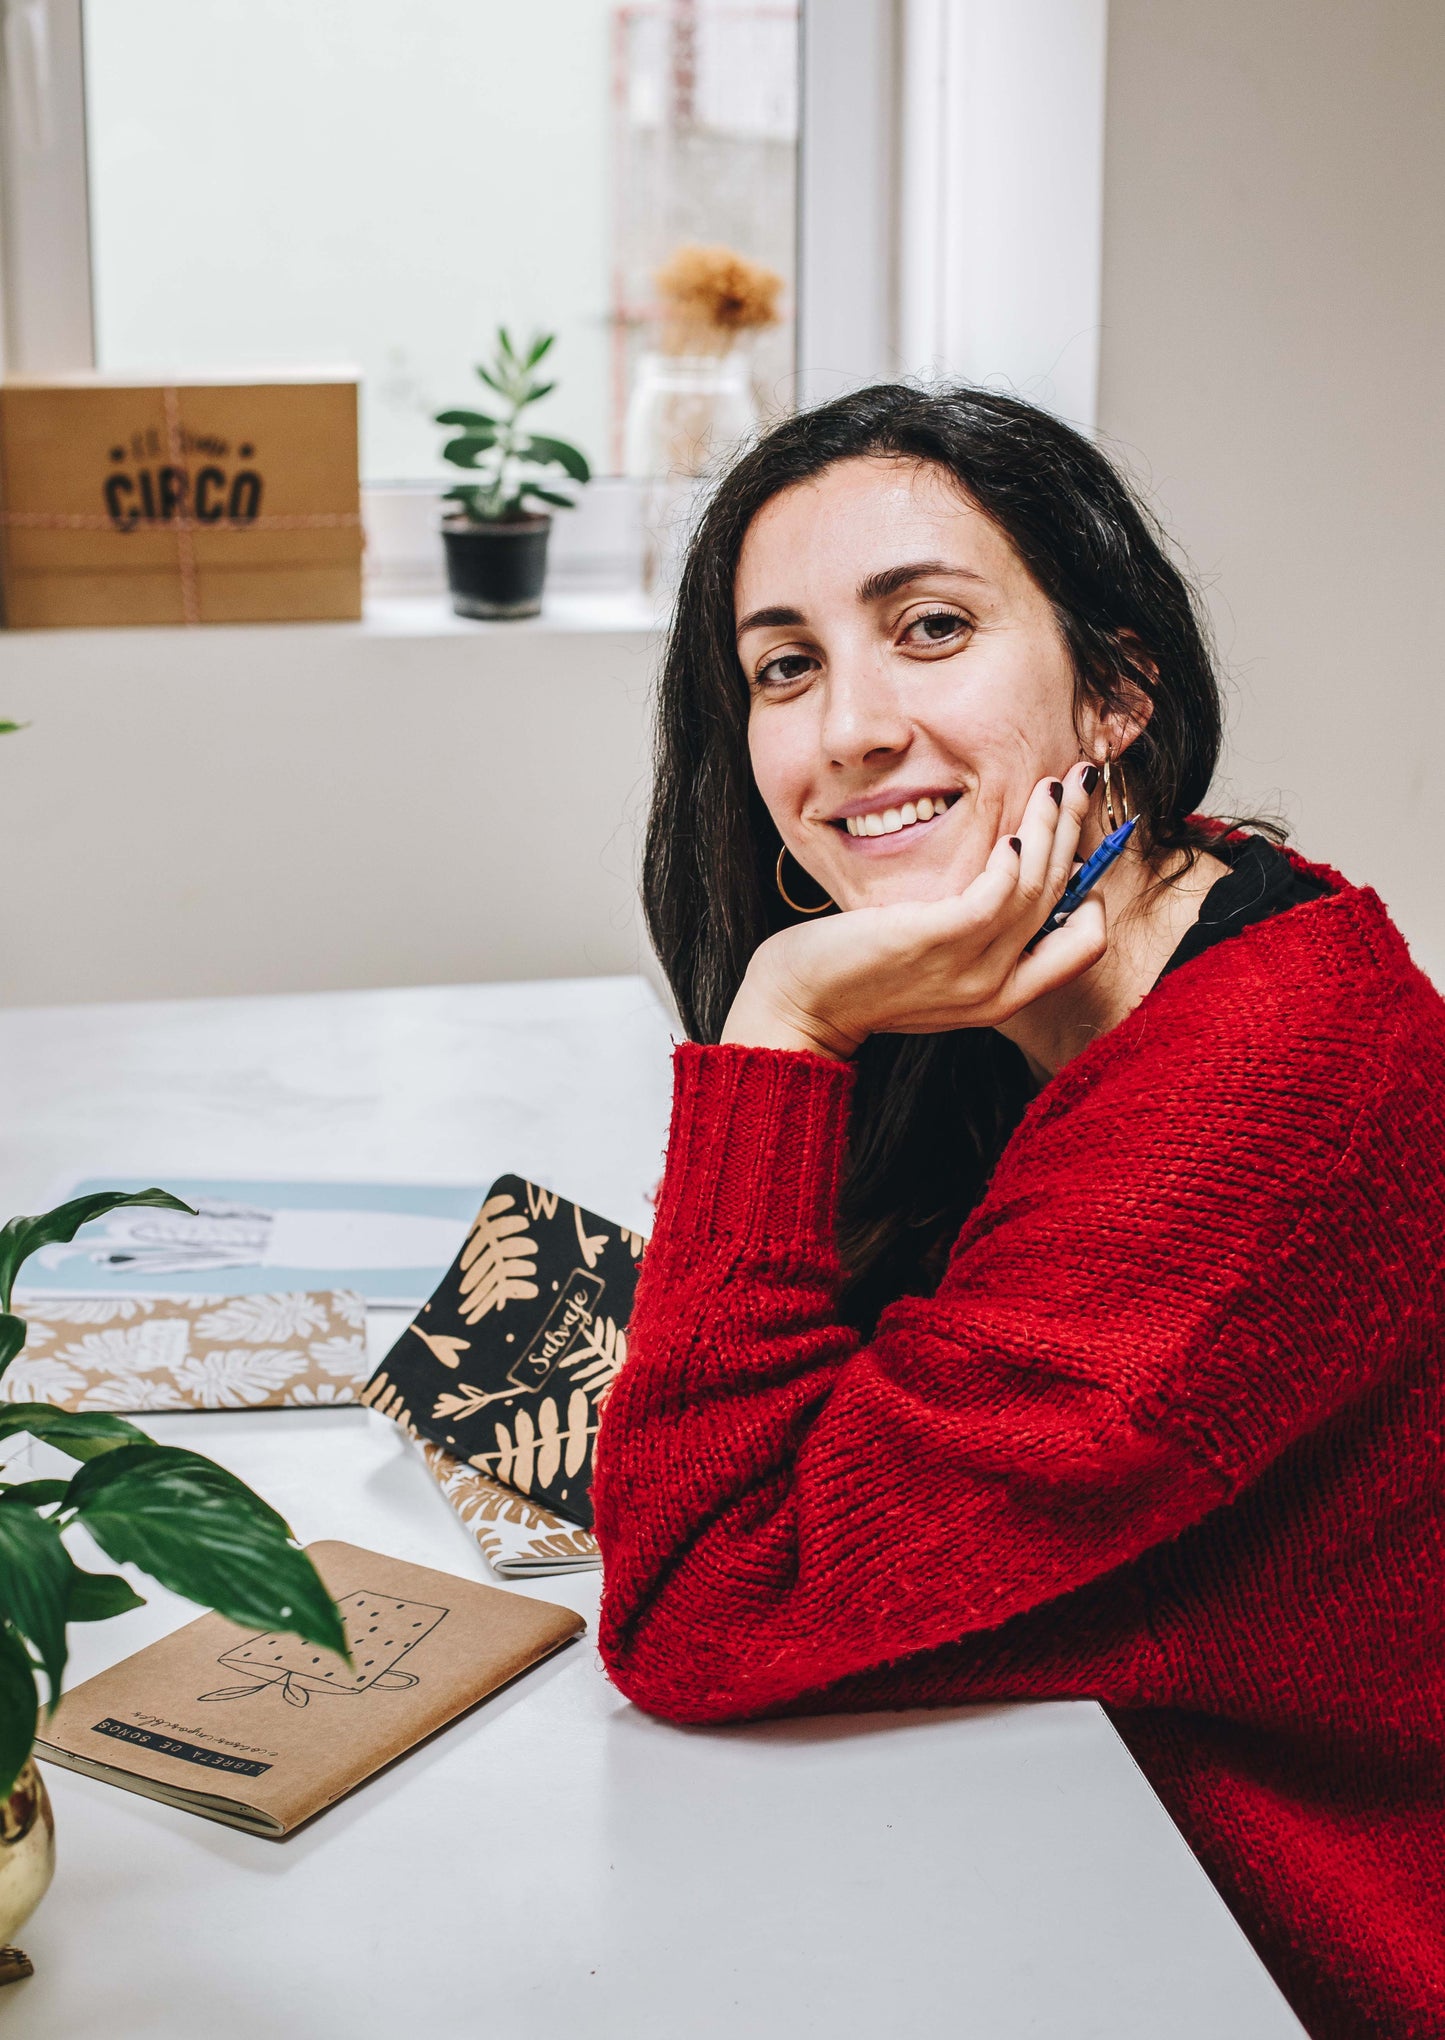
[594,871,1445,2040]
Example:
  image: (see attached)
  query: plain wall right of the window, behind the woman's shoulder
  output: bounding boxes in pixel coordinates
[1100,0,1445,981]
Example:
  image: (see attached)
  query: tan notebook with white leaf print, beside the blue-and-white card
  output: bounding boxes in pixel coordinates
[0,1289,369,1414]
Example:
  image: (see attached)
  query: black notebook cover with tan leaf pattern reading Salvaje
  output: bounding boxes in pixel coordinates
[361,1175,643,1530]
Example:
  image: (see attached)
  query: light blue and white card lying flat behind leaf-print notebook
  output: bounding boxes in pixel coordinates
[18,1173,482,1308]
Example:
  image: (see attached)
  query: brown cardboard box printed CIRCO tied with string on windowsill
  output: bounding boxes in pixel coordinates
[0,371,361,630]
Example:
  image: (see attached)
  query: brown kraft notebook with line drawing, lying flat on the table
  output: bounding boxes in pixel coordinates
[35,1544,586,1838]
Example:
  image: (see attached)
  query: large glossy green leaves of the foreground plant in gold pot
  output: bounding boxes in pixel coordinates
[0,1189,351,1799]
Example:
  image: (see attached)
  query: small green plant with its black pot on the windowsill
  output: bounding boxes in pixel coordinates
[437,326,592,616]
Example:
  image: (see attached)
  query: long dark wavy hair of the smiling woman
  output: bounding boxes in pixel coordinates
[643,384,1223,1328]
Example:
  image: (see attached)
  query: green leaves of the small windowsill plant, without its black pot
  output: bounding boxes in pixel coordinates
[437,326,592,524]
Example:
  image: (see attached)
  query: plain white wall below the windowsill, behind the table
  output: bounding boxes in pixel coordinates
[0,604,651,1006]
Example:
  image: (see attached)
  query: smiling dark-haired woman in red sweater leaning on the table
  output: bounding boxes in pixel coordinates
[596,388,1445,2040]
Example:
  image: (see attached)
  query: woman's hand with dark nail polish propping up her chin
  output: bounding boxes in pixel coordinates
[723,765,1108,1059]
